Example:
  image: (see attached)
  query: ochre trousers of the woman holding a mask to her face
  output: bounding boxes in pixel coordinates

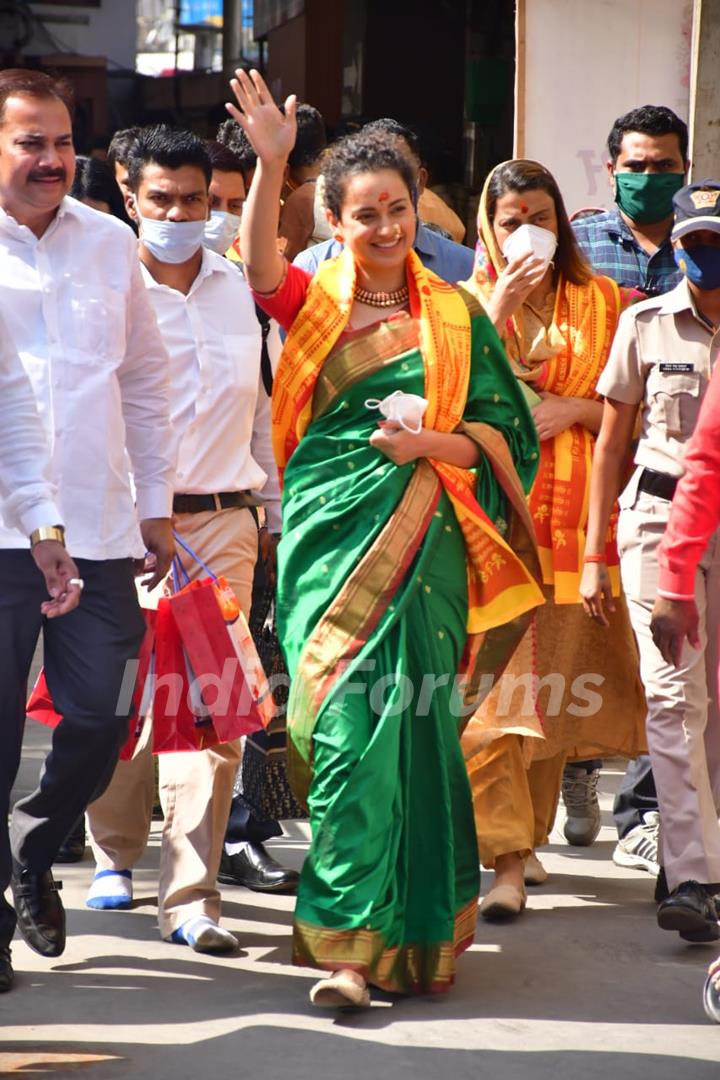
[467,733,567,869]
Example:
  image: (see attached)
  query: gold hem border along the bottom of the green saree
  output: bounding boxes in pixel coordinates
[293,896,477,994]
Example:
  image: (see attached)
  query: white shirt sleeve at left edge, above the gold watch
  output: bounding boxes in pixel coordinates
[0,311,63,536]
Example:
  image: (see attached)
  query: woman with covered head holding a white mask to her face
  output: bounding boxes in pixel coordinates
[463,160,646,918]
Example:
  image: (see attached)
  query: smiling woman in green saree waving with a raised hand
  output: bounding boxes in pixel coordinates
[228,72,542,1007]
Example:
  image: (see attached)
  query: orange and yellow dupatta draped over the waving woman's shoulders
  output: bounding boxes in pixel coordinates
[272,249,543,634]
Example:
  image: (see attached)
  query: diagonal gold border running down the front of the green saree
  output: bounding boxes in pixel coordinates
[287,460,440,802]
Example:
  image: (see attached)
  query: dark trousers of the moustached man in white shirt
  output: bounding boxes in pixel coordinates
[0,550,145,944]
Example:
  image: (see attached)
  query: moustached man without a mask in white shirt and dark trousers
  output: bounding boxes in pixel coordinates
[0,69,174,972]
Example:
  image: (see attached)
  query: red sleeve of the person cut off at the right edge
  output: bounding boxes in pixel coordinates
[657,365,720,599]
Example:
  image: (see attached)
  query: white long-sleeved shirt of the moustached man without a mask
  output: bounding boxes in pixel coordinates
[0,197,176,559]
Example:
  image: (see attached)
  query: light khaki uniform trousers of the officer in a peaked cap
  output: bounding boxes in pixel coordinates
[617,491,720,889]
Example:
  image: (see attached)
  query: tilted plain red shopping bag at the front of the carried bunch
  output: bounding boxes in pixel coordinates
[168,578,263,742]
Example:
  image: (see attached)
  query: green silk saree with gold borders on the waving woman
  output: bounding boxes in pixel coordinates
[277,300,538,993]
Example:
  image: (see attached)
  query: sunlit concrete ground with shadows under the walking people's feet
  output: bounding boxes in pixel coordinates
[0,726,720,1080]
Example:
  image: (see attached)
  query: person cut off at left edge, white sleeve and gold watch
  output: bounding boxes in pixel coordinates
[0,321,82,994]
